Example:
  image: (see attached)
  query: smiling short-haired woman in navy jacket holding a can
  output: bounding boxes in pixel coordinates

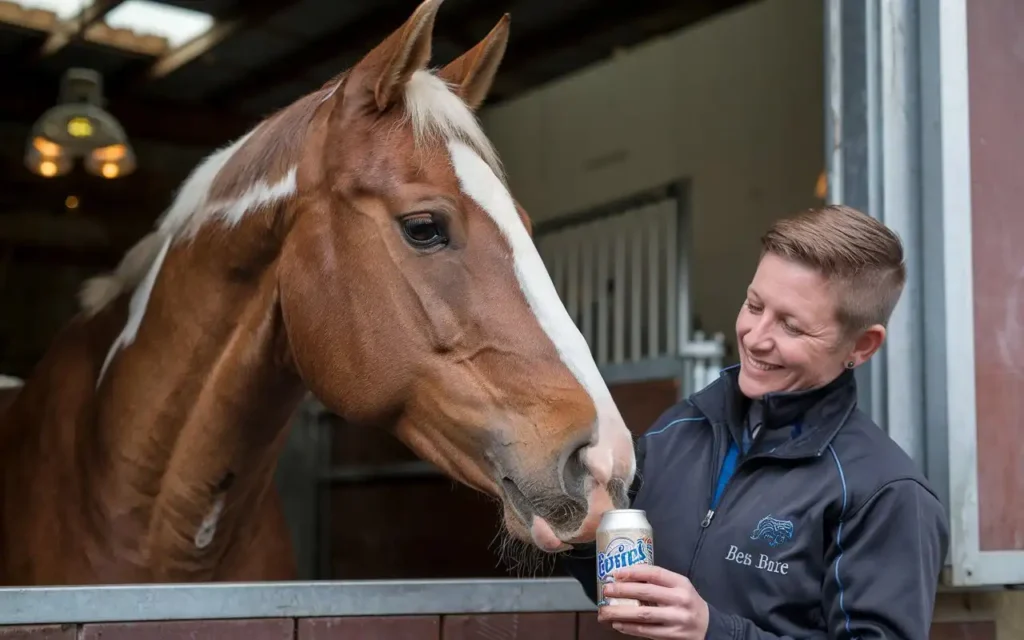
[564,207,948,640]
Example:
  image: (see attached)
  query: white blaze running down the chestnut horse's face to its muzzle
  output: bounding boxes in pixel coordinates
[449,140,636,483]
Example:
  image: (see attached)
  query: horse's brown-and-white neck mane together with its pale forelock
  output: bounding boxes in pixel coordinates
[79,71,506,315]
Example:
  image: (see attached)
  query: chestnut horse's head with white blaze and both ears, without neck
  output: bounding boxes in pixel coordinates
[280,0,635,551]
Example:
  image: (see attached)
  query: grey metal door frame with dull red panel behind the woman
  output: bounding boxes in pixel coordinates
[824,0,1024,589]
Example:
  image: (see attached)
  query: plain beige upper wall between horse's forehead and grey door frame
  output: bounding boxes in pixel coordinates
[482,0,824,350]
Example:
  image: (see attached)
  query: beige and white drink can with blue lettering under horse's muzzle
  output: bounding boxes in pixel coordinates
[597,509,654,606]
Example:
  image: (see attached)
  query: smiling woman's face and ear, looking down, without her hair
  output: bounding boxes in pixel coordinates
[736,253,885,398]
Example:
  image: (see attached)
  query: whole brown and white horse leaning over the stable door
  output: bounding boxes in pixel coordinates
[0,0,635,585]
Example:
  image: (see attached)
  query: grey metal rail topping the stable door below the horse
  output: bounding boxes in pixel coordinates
[0,577,595,626]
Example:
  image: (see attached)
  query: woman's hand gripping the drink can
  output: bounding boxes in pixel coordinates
[597,564,709,640]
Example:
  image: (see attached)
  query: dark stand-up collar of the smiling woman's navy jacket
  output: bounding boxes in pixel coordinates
[690,365,857,458]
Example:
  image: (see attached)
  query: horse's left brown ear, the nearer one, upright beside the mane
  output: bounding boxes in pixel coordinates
[352,0,443,111]
